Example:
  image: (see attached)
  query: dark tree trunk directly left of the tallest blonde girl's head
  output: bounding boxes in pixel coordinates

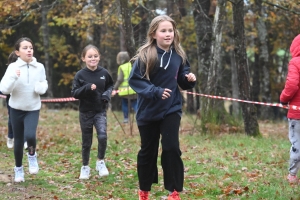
[119,0,135,57]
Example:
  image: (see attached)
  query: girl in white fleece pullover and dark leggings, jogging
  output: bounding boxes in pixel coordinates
[0,37,48,182]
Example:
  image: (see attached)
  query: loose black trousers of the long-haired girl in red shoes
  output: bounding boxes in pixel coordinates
[137,113,184,192]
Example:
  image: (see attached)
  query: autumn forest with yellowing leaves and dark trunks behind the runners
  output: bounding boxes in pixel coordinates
[0,0,300,136]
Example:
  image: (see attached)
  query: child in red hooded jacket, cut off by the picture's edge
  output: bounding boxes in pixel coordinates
[280,34,300,183]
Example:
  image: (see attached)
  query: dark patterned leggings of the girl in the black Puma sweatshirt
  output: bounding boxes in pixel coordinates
[79,111,107,166]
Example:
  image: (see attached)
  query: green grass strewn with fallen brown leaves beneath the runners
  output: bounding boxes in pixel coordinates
[0,108,300,200]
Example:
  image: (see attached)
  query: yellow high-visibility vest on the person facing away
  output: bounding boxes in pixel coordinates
[118,62,136,96]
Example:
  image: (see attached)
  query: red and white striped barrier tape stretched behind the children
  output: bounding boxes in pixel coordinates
[0,90,300,110]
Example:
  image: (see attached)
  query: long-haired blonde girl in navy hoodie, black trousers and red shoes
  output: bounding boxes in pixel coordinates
[129,15,196,200]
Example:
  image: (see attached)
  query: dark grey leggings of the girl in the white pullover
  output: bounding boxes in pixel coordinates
[10,108,40,167]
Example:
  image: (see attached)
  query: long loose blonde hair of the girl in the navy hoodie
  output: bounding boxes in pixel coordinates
[131,15,186,79]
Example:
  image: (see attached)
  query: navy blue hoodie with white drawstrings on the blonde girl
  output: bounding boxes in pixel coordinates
[129,47,196,126]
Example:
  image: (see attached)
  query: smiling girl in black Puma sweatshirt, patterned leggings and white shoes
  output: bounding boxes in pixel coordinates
[71,45,113,179]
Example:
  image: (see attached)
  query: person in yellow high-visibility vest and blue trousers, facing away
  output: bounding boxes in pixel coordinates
[112,51,137,123]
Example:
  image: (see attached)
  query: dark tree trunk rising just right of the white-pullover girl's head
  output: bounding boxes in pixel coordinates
[42,1,53,97]
